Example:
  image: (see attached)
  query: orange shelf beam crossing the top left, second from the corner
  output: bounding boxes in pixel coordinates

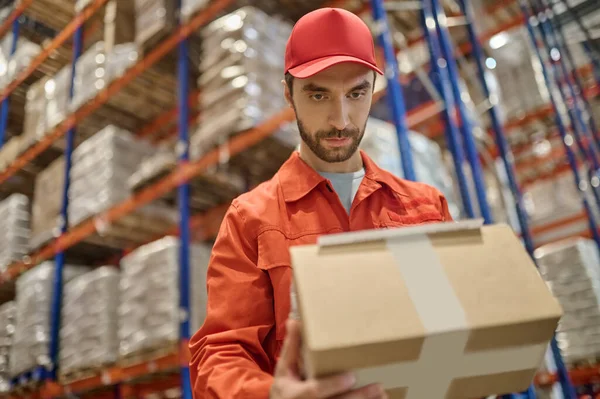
[0,0,107,101]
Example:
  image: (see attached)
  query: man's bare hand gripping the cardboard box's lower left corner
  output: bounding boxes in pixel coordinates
[270,319,387,399]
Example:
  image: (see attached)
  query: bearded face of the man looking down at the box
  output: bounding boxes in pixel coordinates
[285,63,375,163]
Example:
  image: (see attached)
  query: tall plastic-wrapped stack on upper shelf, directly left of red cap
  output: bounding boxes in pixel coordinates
[190,7,291,158]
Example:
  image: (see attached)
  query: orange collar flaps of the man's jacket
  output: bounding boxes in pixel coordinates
[277,150,402,202]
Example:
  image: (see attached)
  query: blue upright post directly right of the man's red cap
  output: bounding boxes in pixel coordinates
[371,0,417,181]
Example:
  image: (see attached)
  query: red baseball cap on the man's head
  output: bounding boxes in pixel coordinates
[285,7,383,79]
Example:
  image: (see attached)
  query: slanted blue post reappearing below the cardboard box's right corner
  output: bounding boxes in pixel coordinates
[458,0,577,399]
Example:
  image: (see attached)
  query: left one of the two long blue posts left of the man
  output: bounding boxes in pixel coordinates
[50,26,83,380]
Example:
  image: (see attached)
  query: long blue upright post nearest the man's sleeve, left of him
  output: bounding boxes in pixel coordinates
[177,2,192,399]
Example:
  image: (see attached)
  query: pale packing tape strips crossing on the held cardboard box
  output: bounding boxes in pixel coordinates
[355,234,547,399]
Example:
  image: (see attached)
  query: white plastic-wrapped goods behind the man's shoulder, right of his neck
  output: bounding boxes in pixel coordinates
[361,118,460,218]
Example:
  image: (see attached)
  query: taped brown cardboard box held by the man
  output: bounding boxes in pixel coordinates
[290,221,562,399]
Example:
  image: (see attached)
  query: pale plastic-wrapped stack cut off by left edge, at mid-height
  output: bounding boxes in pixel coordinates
[0,194,31,271]
